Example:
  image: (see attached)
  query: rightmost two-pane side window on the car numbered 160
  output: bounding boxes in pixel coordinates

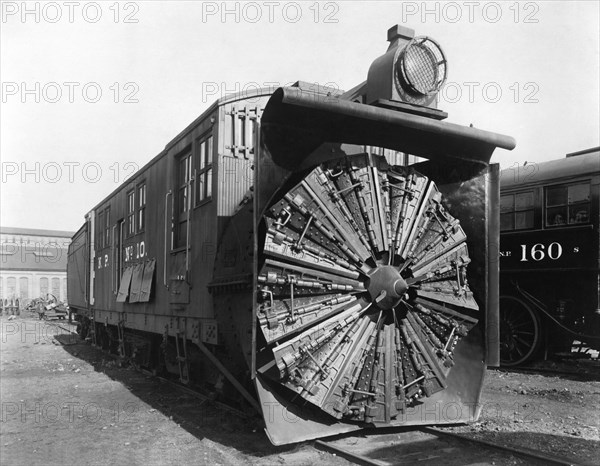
[545,182,590,227]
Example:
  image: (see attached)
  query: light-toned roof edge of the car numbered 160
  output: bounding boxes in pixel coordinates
[500,148,600,191]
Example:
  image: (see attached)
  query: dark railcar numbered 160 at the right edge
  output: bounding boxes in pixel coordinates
[500,148,600,366]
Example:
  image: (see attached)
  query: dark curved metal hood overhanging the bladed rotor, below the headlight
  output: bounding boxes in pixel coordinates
[261,87,516,170]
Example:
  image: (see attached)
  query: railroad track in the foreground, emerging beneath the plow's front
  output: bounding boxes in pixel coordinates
[314,427,577,466]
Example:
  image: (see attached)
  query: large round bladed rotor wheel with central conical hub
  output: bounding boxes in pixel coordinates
[257,155,479,423]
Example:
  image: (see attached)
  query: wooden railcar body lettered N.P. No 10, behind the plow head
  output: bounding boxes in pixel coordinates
[69,89,271,390]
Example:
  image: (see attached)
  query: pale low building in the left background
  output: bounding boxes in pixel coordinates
[0,227,73,307]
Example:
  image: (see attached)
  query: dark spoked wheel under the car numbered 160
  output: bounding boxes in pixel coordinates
[500,296,541,367]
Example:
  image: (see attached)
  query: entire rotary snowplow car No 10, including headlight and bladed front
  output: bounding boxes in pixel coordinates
[68,26,515,444]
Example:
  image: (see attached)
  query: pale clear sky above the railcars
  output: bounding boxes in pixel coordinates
[0,0,600,231]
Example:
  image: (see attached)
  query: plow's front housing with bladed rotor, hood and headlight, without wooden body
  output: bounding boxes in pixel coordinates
[251,24,514,444]
